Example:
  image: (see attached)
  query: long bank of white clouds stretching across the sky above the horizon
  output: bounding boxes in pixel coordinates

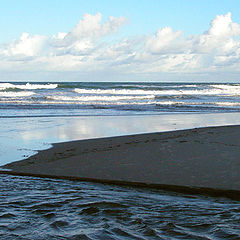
[0,13,240,81]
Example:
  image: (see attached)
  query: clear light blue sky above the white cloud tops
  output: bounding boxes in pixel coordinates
[0,0,240,40]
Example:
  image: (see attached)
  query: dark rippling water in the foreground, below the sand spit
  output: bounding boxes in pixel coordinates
[0,175,240,240]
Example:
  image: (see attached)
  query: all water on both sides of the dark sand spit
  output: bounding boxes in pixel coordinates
[0,82,240,240]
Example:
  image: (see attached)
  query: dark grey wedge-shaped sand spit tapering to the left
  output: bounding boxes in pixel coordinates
[3,126,240,197]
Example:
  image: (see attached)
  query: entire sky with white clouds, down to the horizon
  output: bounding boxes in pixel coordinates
[0,0,240,83]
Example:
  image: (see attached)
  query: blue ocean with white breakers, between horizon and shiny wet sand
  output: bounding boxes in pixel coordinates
[0,82,240,117]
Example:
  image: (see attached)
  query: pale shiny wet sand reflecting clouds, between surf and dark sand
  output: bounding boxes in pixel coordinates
[0,113,240,165]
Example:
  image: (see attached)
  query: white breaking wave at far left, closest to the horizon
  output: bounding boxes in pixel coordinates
[0,83,58,91]
